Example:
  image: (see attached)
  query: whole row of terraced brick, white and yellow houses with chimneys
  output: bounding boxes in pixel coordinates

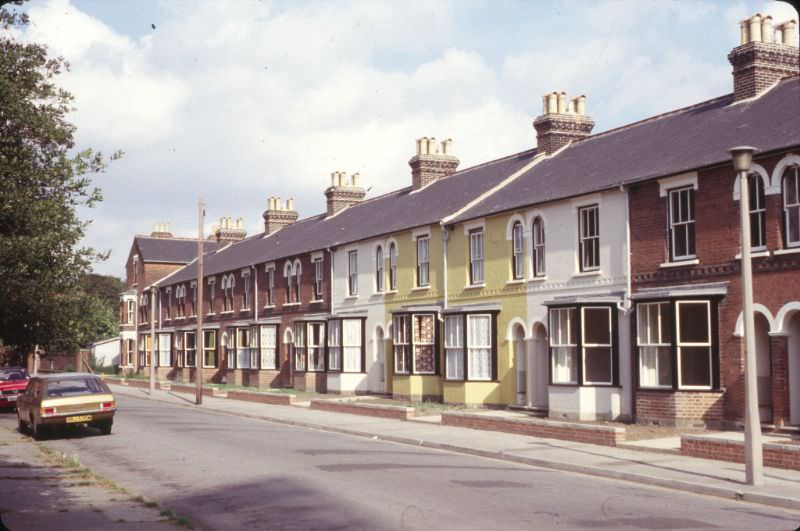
[121,15,800,425]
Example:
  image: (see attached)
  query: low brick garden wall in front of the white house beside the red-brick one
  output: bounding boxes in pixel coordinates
[442,411,625,446]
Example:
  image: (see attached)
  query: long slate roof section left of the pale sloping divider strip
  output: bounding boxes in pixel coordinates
[158,149,536,286]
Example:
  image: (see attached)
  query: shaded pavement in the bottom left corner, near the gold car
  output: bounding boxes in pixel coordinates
[0,425,176,531]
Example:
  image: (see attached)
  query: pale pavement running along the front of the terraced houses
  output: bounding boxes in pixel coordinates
[111,384,800,510]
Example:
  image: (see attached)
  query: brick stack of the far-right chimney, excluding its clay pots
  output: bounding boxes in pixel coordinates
[728,42,800,101]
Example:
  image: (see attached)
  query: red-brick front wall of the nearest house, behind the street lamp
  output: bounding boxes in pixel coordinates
[630,150,800,425]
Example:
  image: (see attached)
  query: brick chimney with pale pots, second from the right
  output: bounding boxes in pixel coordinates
[533,92,594,153]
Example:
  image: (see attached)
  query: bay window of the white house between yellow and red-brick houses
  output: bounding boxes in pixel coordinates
[550,304,617,386]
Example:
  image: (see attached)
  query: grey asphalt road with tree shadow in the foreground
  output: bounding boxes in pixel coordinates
[6,396,800,530]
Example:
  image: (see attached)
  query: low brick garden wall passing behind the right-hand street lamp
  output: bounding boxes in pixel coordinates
[681,435,800,470]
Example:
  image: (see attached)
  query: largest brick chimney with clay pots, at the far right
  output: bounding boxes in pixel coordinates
[728,13,800,101]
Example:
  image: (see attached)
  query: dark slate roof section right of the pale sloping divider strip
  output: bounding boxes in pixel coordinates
[448,76,800,223]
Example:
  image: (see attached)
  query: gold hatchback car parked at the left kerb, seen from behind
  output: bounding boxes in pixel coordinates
[17,373,116,438]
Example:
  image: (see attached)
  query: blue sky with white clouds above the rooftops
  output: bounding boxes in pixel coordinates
[7,0,797,276]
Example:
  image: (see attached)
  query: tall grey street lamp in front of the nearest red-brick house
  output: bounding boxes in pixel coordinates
[730,146,764,485]
